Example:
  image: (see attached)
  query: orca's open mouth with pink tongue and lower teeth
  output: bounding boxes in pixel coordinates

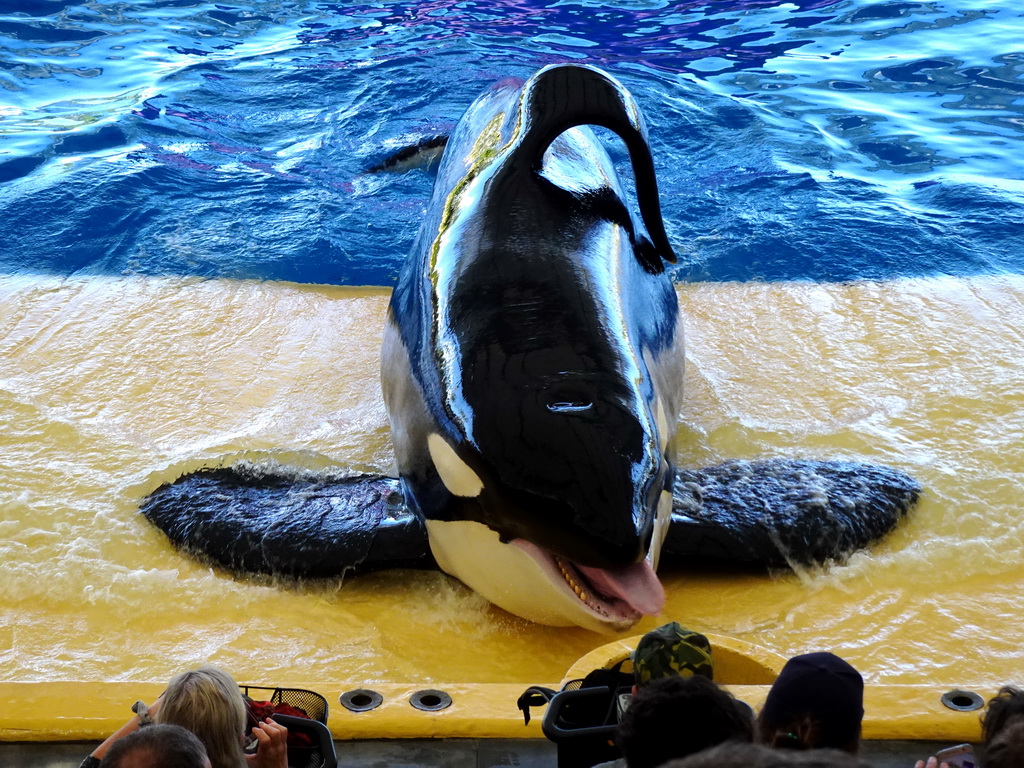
[512,539,665,625]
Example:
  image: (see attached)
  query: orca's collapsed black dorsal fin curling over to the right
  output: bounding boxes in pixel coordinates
[519,65,676,271]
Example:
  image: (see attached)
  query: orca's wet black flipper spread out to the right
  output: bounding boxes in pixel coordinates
[662,459,921,567]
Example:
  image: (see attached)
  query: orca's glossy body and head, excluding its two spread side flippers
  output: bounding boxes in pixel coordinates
[382,66,683,629]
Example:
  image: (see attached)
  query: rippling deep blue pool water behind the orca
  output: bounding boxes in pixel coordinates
[0,0,1024,286]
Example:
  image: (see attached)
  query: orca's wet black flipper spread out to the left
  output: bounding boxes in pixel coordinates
[141,464,434,579]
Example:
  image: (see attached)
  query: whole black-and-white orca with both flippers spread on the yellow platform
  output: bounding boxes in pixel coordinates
[142,65,920,632]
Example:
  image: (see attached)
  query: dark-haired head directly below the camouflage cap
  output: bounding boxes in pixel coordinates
[617,675,754,768]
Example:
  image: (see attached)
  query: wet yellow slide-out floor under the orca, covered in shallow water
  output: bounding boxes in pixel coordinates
[0,276,1024,712]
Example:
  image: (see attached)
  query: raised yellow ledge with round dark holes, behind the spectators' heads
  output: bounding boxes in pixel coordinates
[0,635,994,742]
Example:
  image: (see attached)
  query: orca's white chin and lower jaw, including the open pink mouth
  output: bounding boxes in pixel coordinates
[426,499,667,633]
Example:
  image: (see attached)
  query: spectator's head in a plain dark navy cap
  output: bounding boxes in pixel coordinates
[758,652,864,755]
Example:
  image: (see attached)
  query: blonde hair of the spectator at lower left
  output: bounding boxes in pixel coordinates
[157,667,246,768]
